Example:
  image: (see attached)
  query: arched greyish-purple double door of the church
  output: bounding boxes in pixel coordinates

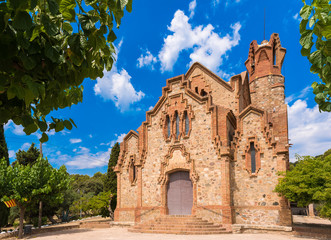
[167,171,193,215]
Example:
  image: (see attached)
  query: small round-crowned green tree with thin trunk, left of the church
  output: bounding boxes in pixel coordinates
[0,158,70,238]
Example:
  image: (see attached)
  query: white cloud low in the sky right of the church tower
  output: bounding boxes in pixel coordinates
[288,99,331,162]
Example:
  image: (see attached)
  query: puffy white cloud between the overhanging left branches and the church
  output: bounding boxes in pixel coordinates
[94,41,145,112]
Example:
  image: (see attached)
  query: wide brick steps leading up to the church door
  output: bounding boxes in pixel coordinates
[129,215,231,234]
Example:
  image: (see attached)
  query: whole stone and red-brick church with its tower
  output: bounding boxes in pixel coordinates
[114,33,291,226]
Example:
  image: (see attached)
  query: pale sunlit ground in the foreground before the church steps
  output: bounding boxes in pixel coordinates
[27,227,315,240]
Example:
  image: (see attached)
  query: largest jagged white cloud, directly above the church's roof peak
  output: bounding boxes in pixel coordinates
[159,10,241,72]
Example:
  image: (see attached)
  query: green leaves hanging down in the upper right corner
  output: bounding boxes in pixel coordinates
[300,0,331,112]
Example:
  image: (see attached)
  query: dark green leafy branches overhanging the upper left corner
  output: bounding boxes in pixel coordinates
[0,0,132,142]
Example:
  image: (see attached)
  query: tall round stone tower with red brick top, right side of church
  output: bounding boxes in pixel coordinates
[245,33,292,226]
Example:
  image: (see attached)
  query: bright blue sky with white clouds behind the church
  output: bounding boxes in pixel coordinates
[5,0,331,175]
